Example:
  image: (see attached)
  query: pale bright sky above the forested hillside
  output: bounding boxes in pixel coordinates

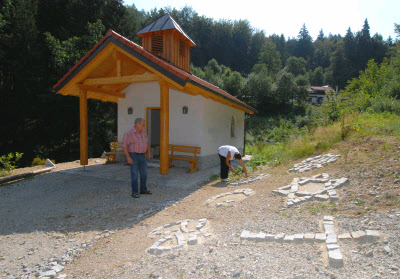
[124,0,400,40]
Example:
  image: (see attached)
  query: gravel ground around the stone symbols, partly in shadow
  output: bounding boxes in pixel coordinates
[0,138,400,279]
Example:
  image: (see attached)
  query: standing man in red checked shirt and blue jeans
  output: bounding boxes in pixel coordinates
[123,118,152,198]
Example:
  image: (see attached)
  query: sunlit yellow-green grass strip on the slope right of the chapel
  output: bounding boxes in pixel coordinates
[247,112,400,170]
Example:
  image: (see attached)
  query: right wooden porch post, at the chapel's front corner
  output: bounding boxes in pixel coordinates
[159,82,169,175]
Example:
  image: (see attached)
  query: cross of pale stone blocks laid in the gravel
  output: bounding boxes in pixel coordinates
[240,216,380,268]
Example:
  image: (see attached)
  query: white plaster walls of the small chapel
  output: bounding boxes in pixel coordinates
[117,82,245,157]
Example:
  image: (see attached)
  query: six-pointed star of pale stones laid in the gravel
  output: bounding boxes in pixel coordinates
[273,173,350,207]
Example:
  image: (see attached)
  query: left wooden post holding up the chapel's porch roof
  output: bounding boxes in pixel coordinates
[79,89,88,165]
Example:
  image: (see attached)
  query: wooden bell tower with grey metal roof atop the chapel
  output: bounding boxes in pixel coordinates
[136,14,196,72]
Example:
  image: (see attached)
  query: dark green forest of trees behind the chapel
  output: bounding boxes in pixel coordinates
[0,0,400,166]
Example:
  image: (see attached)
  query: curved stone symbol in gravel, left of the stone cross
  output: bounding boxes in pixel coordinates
[147,219,211,256]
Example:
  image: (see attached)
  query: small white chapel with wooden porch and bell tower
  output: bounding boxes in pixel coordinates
[53,14,256,174]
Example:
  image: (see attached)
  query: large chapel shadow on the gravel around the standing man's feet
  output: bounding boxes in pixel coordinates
[0,163,218,235]
